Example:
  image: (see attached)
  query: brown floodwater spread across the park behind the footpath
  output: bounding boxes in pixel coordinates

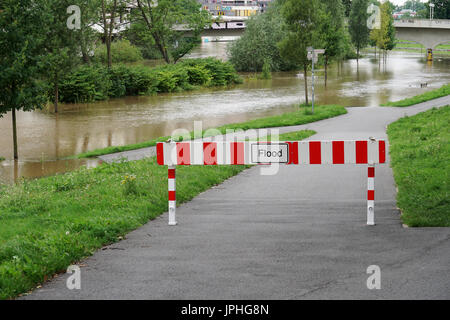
[0,42,450,182]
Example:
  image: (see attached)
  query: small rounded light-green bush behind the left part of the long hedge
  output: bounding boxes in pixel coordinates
[94,40,143,64]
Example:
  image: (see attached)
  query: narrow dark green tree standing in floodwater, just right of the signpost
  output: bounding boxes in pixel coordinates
[321,0,345,87]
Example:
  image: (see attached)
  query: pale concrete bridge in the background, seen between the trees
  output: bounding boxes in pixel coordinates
[184,17,450,59]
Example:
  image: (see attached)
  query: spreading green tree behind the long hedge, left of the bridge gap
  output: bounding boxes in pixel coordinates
[134,0,211,63]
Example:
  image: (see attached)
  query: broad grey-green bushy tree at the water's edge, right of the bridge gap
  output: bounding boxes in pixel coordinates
[228,2,297,72]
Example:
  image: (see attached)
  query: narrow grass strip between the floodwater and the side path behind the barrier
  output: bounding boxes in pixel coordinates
[71,105,347,159]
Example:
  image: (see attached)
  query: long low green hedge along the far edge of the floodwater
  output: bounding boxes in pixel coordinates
[60,58,242,103]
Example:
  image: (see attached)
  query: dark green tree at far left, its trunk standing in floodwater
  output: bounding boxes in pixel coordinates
[0,0,48,159]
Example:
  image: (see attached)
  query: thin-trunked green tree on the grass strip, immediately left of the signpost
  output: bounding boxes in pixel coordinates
[279,0,326,104]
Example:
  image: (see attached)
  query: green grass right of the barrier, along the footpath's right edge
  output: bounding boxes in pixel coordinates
[388,106,450,227]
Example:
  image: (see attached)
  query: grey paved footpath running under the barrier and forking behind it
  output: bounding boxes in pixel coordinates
[25,96,450,299]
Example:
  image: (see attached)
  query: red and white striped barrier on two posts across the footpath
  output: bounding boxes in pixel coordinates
[156,139,386,225]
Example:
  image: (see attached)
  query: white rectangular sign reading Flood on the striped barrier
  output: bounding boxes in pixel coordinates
[251,142,289,164]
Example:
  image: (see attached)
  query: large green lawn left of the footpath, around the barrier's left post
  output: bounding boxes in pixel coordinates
[0,131,315,299]
